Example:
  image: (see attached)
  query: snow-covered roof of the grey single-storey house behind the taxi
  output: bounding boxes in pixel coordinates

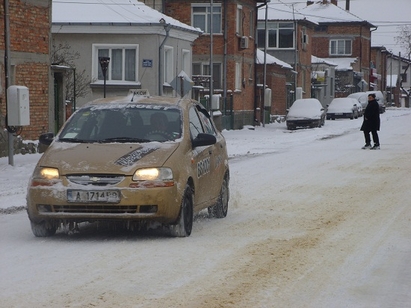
[52,0,202,33]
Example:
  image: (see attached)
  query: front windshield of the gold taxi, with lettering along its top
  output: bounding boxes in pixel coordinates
[58,105,182,143]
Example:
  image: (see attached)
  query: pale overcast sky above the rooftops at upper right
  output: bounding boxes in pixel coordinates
[271,0,411,56]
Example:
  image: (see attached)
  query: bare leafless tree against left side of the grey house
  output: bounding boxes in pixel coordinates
[51,42,90,102]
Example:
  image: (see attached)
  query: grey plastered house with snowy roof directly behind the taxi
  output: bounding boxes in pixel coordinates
[51,0,202,110]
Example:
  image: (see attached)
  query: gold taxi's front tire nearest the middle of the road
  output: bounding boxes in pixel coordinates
[170,185,194,237]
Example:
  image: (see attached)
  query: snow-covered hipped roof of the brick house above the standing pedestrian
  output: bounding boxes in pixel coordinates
[299,1,374,27]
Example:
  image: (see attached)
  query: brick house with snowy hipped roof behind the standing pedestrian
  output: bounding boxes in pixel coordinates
[300,0,376,97]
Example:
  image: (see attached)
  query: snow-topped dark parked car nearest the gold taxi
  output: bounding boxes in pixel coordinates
[285,98,325,130]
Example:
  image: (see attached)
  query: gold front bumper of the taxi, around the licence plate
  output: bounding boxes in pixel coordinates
[27,181,182,223]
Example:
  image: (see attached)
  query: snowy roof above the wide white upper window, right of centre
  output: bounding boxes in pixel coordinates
[258,1,316,23]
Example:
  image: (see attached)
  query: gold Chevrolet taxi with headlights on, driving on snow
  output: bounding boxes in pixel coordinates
[27,90,229,237]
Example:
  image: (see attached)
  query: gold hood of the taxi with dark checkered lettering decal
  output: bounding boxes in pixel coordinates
[38,142,180,175]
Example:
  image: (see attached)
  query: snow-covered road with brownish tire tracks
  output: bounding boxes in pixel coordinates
[0,109,411,308]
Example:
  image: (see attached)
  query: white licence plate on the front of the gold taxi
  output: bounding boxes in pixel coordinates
[67,190,120,203]
